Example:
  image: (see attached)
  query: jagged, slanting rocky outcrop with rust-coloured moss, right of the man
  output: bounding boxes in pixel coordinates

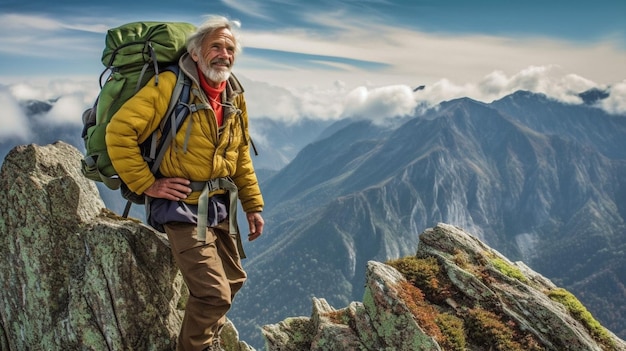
[263,224,626,351]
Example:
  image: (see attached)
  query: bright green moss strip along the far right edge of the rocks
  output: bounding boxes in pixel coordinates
[548,288,616,350]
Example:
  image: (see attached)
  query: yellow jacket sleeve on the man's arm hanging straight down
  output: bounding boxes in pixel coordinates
[233,95,264,212]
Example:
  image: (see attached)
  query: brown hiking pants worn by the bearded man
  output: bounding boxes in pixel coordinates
[164,219,246,351]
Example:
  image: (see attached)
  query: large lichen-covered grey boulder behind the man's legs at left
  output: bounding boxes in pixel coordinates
[0,142,251,351]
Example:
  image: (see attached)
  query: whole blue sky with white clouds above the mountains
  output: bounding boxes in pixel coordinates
[0,0,626,141]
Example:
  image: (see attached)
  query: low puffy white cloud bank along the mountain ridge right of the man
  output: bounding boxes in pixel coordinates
[242,66,626,123]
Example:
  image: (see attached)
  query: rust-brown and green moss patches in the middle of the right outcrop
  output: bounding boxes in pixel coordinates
[387,255,543,351]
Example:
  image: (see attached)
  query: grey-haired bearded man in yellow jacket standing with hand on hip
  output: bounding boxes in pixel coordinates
[106,17,264,351]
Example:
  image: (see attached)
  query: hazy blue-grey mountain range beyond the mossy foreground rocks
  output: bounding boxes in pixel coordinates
[230,92,626,350]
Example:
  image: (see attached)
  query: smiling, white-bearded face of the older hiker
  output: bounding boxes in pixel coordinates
[191,28,235,86]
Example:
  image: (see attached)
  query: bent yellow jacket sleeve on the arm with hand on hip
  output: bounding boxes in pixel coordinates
[106,72,176,194]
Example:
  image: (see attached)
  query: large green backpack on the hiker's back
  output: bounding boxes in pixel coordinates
[81,22,195,192]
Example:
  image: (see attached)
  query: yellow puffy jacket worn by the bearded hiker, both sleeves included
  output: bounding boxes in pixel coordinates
[106,54,263,212]
